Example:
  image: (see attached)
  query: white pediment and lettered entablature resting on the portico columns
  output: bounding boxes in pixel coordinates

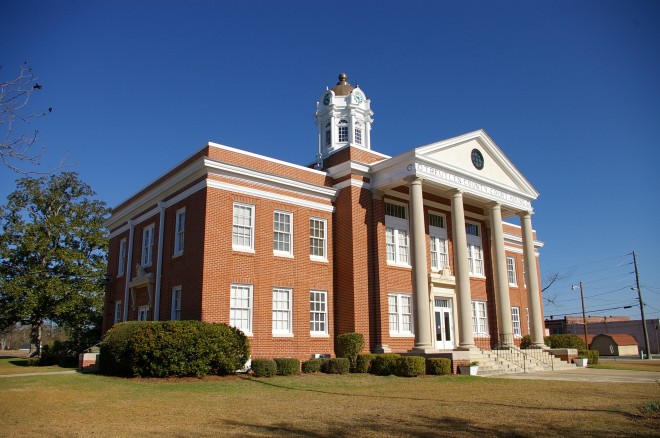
[371,130,539,211]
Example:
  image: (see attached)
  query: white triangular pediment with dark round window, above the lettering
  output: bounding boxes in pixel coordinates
[415,130,538,200]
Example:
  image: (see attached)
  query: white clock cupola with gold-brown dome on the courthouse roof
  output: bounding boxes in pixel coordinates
[314,73,373,160]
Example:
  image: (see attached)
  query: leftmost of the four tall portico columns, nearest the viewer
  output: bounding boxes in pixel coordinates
[409,178,433,349]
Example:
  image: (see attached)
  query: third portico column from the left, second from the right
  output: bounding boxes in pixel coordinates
[490,203,513,347]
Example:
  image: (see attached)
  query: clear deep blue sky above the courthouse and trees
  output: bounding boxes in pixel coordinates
[0,0,660,318]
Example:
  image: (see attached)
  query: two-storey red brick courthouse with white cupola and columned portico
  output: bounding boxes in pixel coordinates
[103,75,544,360]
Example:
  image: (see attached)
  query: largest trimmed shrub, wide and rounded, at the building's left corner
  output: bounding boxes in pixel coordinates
[99,321,250,377]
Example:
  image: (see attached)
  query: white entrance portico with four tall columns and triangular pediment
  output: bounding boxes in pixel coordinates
[371,131,543,352]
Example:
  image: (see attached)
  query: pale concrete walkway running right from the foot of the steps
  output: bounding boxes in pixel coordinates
[485,368,660,385]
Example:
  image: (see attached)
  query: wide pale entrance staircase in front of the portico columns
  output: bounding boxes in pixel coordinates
[470,347,575,376]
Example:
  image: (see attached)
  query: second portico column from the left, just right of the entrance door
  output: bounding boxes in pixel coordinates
[451,190,476,349]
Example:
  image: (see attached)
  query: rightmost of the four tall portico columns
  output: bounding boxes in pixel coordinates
[520,211,545,347]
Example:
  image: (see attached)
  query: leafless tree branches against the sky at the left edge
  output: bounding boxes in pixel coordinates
[0,63,64,174]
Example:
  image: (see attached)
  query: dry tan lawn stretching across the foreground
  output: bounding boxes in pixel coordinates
[0,374,660,437]
